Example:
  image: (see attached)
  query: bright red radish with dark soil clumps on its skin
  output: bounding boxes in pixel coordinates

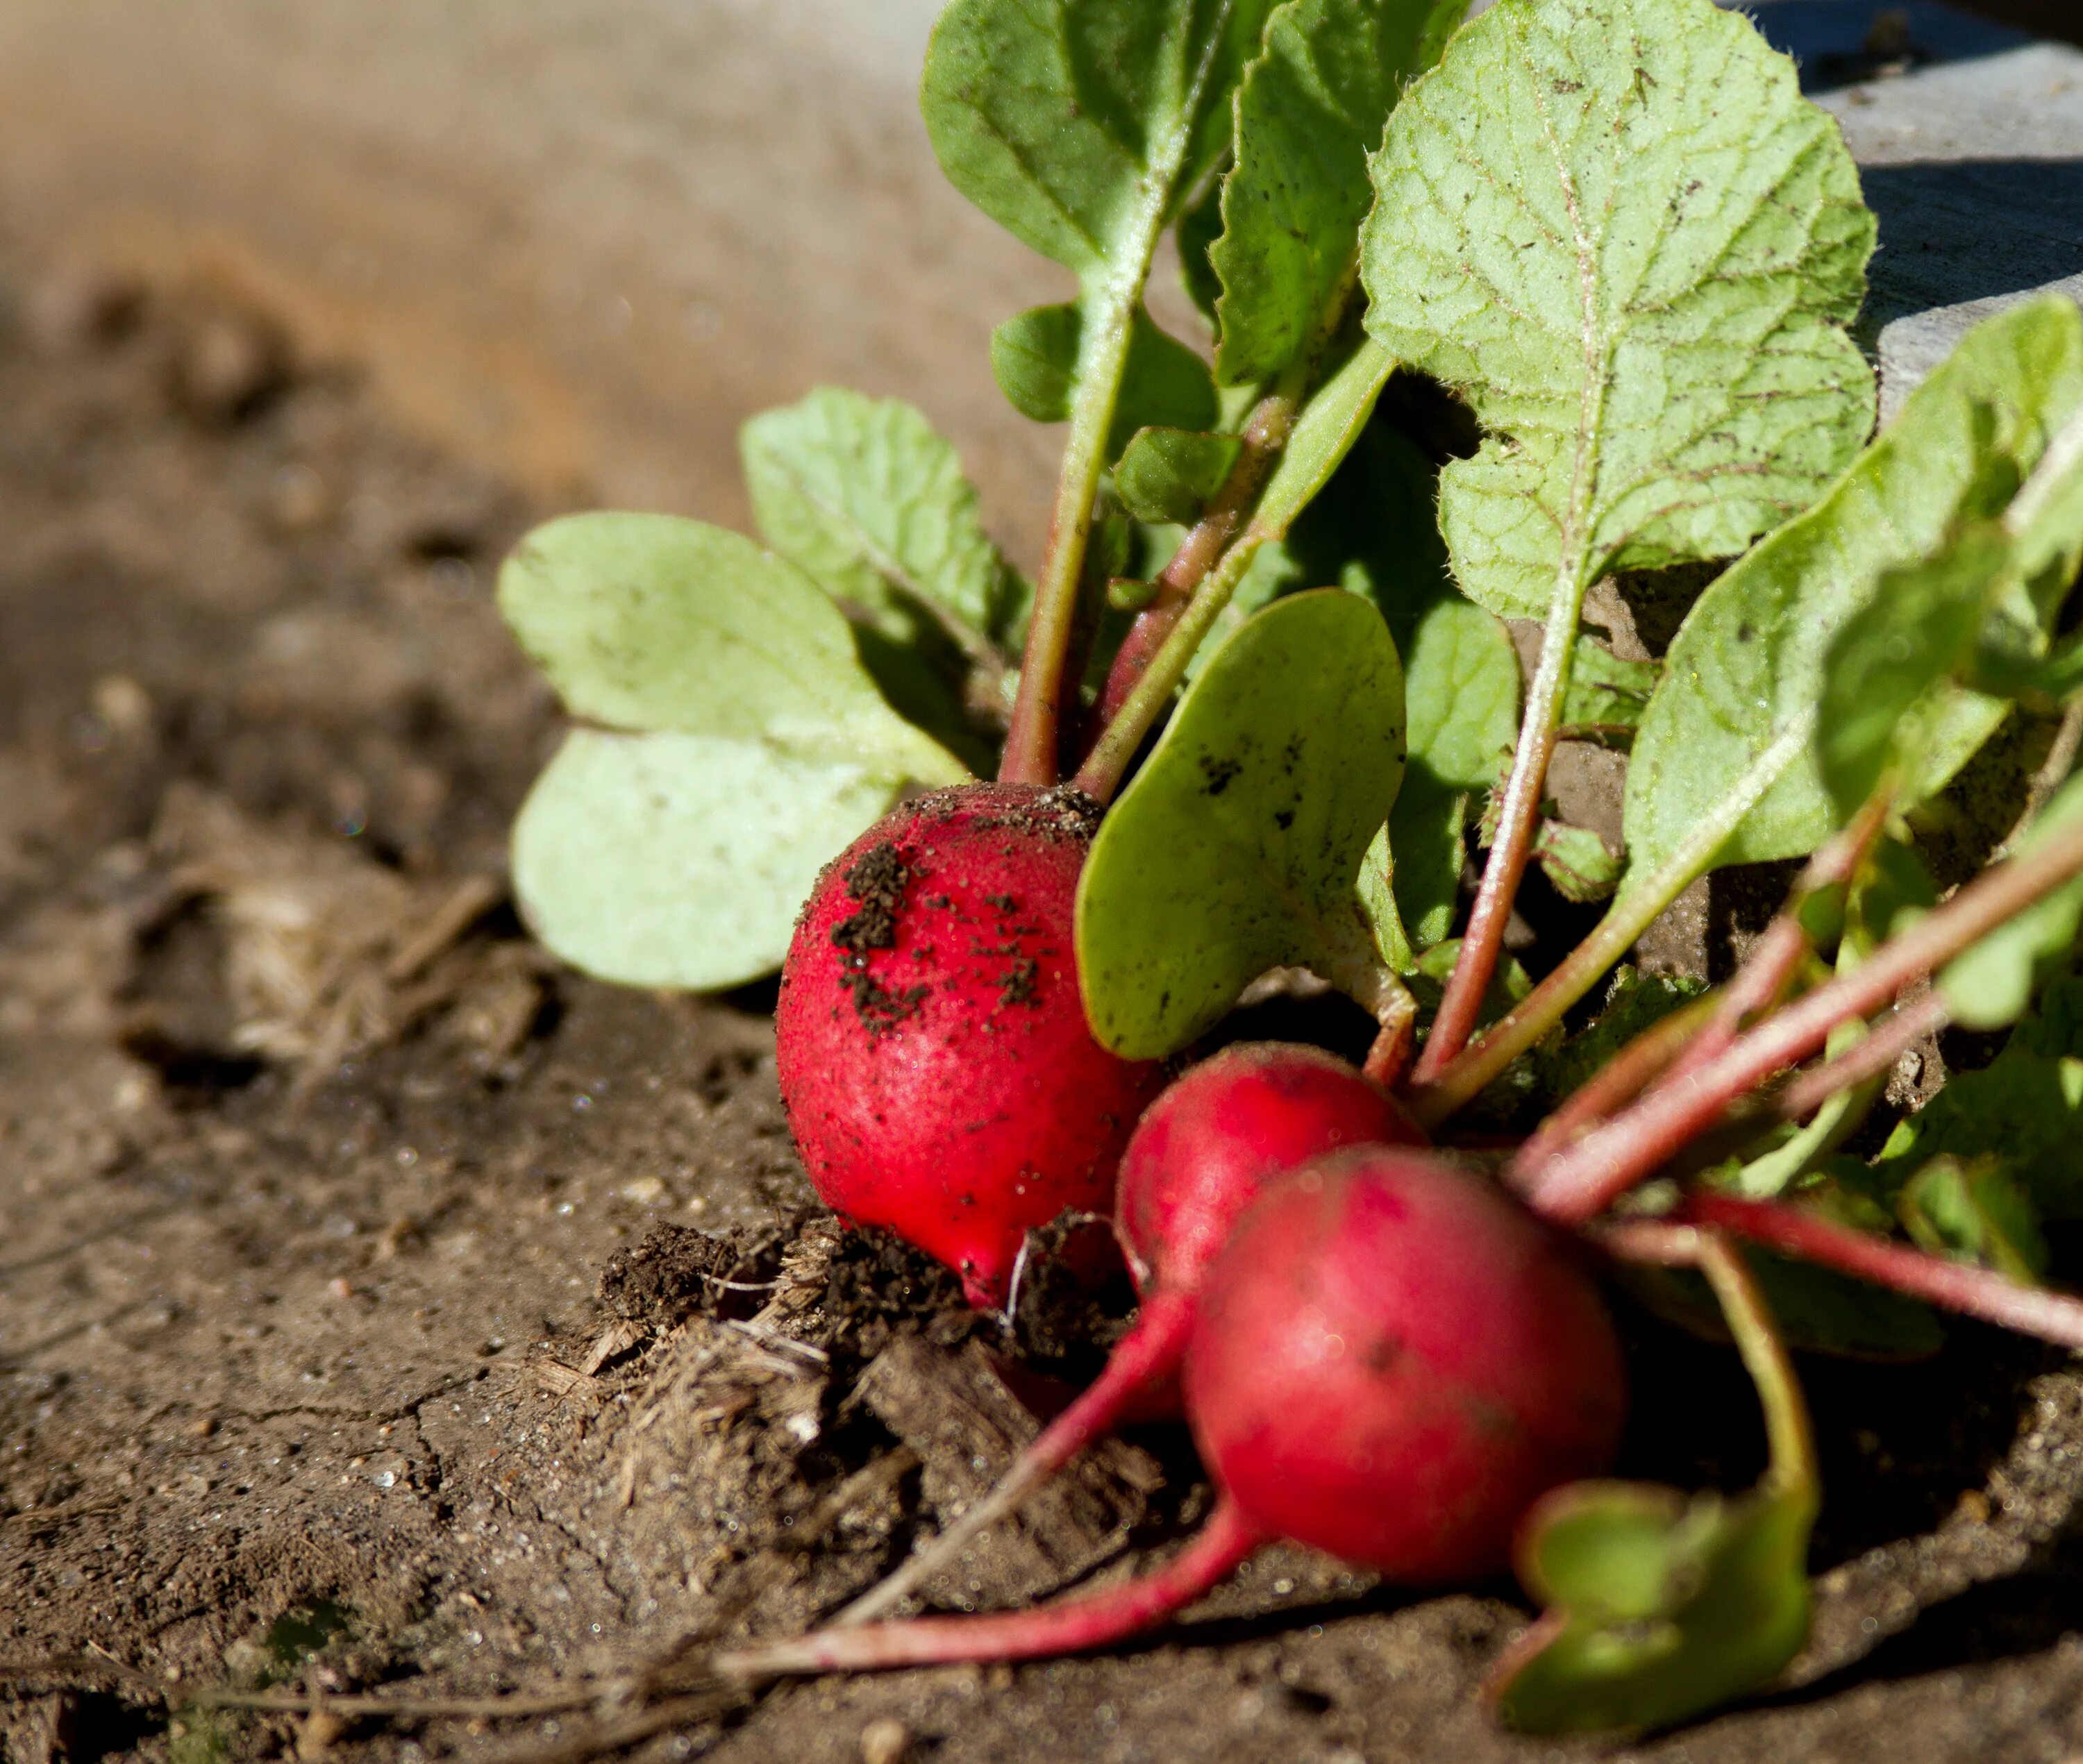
[775,783,1162,1304]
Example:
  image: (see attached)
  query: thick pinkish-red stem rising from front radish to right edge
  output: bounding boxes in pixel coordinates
[1510,827,2083,1225]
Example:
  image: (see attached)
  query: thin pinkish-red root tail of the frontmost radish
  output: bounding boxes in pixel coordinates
[714,1495,1266,1679]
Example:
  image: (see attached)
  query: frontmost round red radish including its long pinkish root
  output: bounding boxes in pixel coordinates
[719,1145,1627,1674]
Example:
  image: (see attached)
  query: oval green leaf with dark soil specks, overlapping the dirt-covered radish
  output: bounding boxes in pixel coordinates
[1077,589,1404,1058]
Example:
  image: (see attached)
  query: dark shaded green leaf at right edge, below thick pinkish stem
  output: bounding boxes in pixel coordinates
[1877,979,2083,1218]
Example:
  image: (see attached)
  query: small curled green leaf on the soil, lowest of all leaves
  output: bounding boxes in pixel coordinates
[1489,1483,1814,1733]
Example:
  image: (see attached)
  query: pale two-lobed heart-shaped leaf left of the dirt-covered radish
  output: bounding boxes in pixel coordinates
[500,514,969,989]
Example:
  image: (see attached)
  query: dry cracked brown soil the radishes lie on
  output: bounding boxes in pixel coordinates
[0,244,2083,1764]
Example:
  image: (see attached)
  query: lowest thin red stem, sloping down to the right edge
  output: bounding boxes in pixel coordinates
[1683,1189,2083,1350]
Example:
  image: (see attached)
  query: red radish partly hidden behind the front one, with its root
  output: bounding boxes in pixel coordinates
[835,1041,1423,1624]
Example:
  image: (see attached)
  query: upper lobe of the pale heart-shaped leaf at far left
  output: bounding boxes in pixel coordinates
[500,514,969,783]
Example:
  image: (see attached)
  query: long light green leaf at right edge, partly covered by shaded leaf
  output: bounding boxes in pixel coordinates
[1625,296,2083,893]
